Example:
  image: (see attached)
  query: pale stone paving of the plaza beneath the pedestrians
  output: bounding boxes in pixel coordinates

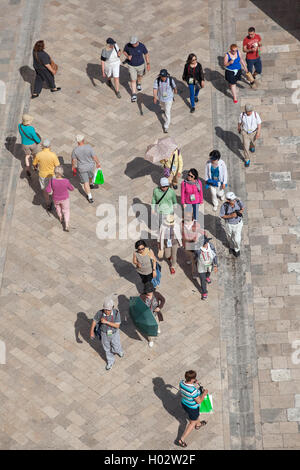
[0,0,300,450]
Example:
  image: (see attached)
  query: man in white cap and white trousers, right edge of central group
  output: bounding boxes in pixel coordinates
[220,192,244,258]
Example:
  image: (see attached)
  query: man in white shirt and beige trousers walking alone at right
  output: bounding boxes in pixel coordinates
[238,104,261,167]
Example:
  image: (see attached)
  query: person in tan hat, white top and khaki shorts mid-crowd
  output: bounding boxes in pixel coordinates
[158,214,182,274]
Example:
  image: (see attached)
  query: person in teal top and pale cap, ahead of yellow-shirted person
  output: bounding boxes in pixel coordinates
[18,114,41,178]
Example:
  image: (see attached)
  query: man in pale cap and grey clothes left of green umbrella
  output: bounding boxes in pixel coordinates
[90,298,124,370]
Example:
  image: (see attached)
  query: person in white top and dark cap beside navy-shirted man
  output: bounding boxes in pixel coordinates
[101,38,121,98]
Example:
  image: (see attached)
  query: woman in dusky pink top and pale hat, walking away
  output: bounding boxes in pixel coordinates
[46,166,74,232]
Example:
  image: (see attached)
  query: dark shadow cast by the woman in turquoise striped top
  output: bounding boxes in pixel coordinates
[152,377,187,444]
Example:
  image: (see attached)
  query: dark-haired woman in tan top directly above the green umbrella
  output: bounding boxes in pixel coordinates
[132,240,156,287]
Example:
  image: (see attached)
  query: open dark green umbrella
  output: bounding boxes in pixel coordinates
[129,297,158,336]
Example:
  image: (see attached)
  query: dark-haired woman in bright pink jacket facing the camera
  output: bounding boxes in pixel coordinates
[181,168,203,221]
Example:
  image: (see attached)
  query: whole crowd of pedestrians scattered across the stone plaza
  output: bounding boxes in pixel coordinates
[19,27,262,447]
